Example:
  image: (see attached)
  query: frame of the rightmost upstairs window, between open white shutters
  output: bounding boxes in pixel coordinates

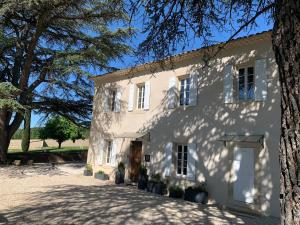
[237,65,255,102]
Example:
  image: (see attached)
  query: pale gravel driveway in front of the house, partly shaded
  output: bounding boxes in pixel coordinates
[0,164,279,225]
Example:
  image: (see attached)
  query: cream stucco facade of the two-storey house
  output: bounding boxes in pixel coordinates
[88,32,280,216]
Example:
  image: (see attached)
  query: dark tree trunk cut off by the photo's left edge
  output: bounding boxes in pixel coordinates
[0,110,10,163]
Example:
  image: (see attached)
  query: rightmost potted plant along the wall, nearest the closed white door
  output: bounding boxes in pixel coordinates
[184,182,208,203]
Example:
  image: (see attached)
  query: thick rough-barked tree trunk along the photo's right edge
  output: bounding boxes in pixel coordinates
[272,0,300,225]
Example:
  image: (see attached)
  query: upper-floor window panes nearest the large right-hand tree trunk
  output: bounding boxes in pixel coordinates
[238,67,254,100]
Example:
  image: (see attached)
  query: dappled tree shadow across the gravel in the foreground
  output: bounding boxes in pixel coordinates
[0,185,277,225]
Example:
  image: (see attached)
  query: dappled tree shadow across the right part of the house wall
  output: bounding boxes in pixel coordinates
[139,51,280,214]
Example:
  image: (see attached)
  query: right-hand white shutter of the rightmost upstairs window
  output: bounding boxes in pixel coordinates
[254,59,268,101]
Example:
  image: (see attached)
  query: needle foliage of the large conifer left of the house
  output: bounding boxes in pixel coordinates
[0,0,133,123]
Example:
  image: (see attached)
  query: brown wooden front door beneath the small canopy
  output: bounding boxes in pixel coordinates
[130,141,143,182]
